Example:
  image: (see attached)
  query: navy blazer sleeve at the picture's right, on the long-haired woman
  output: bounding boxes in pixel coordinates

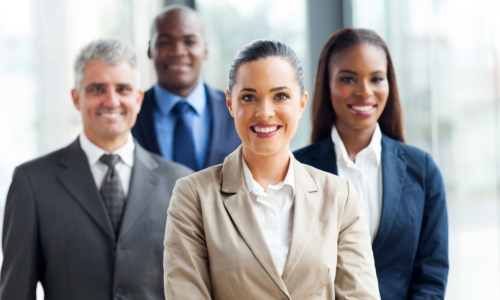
[410,154,449,299]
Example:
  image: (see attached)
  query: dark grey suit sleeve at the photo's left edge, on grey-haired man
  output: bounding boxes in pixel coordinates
[0,167,42,300]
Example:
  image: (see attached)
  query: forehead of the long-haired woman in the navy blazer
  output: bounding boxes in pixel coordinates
[329,43,387,72]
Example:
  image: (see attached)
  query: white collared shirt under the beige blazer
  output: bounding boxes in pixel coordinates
[242,153,295,275]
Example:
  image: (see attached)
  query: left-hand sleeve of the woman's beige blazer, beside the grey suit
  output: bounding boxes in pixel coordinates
[163,179,211,300]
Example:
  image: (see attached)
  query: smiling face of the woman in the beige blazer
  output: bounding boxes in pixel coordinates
[226,57,307,157]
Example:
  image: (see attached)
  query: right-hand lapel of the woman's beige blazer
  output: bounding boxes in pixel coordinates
[282,159,319,284]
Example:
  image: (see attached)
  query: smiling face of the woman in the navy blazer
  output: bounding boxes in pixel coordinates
[329,44,389,131]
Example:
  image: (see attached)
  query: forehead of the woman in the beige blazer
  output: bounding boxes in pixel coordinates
[236,57,300,90]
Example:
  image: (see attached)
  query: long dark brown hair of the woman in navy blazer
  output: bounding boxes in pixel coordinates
[311,28,404,142]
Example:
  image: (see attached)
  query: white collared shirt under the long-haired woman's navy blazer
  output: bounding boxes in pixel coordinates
[332,123,382,243]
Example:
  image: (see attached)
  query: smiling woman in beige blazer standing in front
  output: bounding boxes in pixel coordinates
[164,40,380,300]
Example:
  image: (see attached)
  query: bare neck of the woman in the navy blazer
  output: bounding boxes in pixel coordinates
[335,124,376,161]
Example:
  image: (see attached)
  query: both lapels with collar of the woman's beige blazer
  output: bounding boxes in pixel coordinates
[222,146,319,299]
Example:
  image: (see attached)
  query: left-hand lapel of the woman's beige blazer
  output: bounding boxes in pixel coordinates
[222,146,290,297]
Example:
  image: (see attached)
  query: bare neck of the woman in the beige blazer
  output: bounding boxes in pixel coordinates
[243,146,290,192]
